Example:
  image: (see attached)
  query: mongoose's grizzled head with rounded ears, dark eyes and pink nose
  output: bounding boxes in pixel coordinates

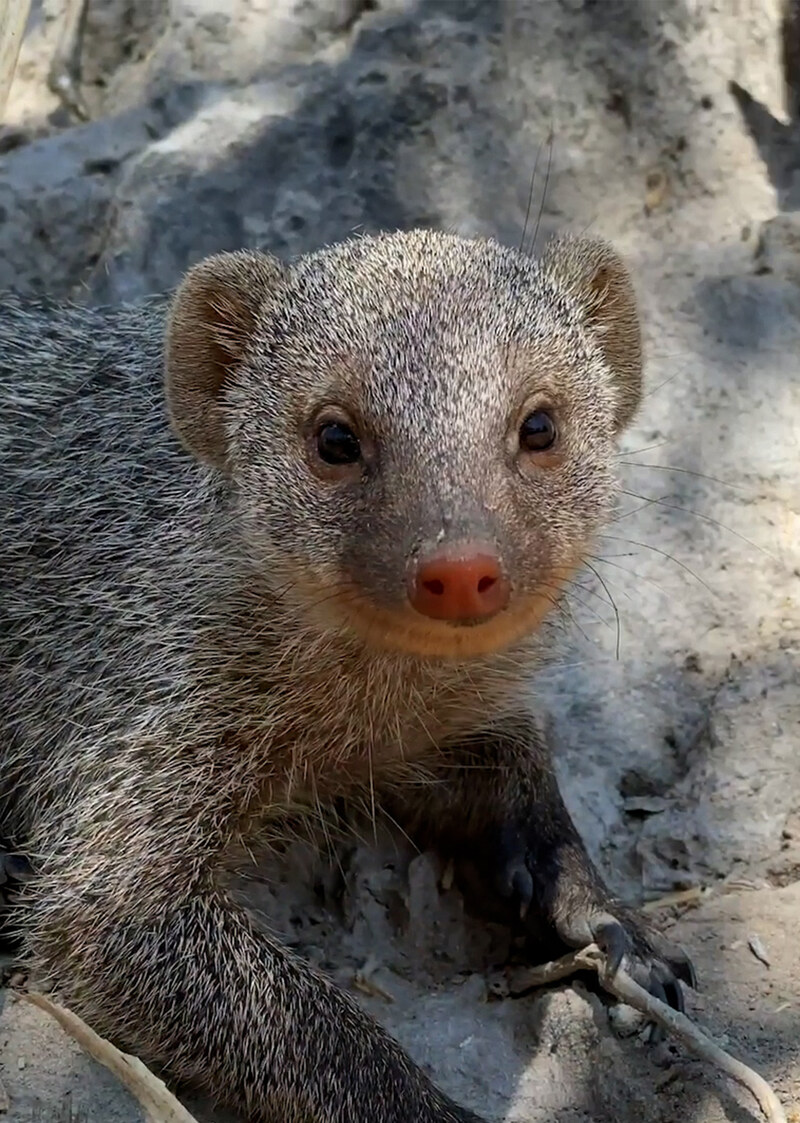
[166,230,642,658]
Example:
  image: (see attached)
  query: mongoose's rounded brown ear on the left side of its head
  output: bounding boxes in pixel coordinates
[165,250,285,469]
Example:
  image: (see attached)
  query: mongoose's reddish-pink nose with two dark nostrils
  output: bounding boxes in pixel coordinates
[408,545,509,621]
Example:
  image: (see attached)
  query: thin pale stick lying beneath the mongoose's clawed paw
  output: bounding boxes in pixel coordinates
[509,943,787,1123]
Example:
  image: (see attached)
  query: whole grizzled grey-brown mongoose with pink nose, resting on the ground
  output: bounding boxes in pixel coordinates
[0,231,693,1123]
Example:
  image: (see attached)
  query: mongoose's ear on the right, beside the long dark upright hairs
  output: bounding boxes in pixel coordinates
[542,235,642,432]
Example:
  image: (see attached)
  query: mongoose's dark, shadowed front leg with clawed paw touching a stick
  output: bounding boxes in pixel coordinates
[384,715,696,1010]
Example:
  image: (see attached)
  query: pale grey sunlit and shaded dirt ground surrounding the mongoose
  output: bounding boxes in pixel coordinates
[0,0,800,1123]
